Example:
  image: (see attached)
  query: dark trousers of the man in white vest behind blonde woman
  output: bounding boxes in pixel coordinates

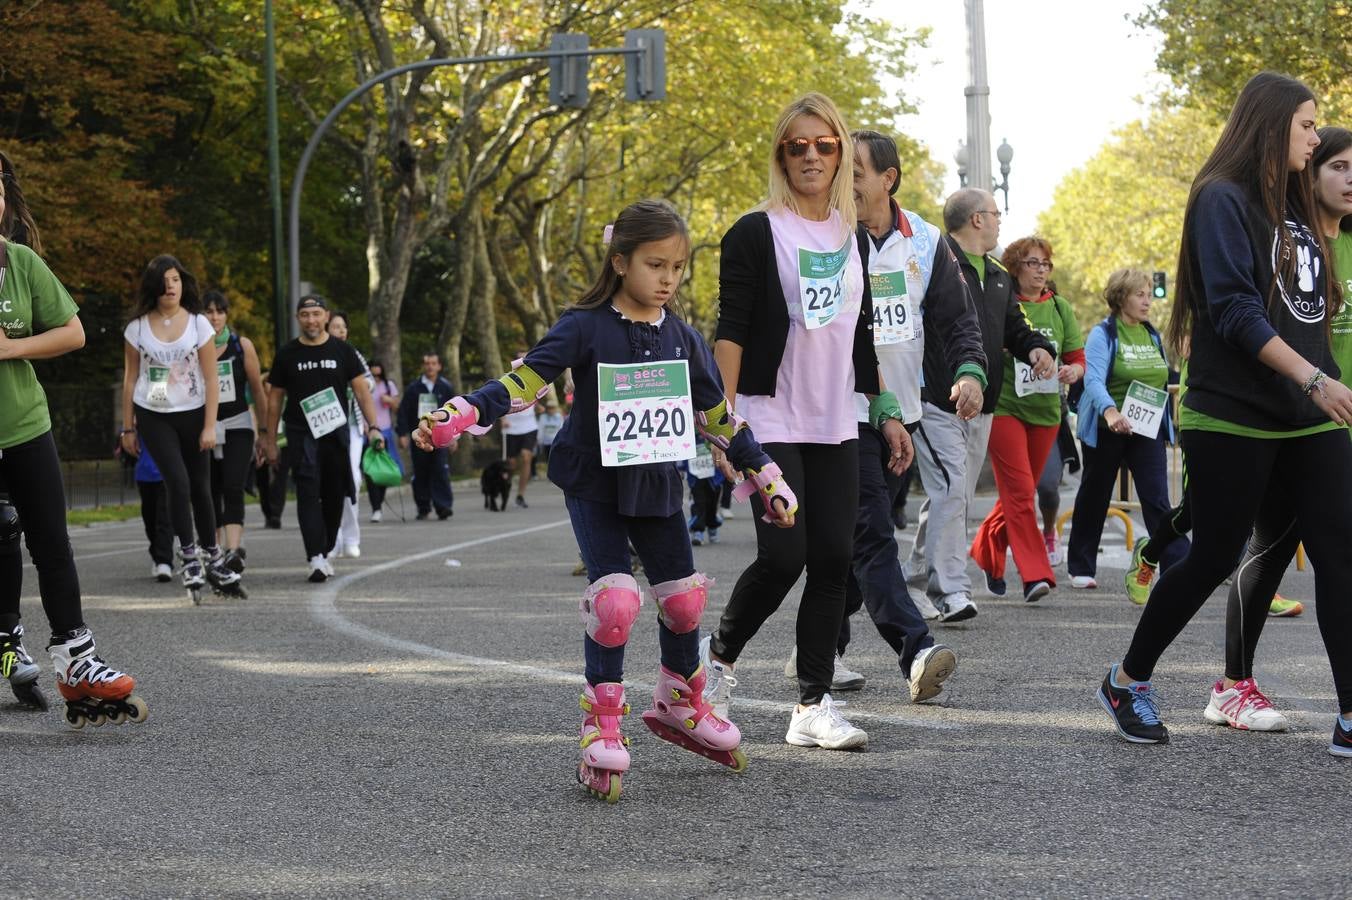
[836,424,934,678]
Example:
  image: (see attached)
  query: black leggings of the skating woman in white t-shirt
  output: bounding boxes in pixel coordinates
[137,407,216,547]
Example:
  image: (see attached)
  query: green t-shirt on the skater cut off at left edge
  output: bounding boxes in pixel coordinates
[0,243,80,450]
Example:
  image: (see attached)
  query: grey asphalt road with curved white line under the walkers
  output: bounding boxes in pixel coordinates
[0,484,1352,897]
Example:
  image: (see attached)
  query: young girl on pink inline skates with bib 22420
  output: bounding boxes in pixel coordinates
[414,200,798,803]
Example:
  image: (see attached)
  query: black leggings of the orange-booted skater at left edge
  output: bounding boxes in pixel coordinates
[0,431,84,635]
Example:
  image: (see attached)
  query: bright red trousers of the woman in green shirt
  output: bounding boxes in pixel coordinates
[972,415,1059,588]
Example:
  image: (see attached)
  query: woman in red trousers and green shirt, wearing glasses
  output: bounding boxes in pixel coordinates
[972,236,1084,603]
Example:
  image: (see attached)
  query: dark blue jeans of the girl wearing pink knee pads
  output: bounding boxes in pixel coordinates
[564,495,699,684]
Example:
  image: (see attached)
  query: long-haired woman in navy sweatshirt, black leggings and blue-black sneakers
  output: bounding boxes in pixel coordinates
[1098,73,1352,755]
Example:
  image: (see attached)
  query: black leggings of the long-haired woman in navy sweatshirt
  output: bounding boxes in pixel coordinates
[1122,428,1352,712]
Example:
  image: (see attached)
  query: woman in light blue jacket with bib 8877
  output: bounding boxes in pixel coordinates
[1065,269,1188,588]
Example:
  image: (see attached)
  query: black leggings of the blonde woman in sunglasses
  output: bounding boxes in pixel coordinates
[710,439,859,704]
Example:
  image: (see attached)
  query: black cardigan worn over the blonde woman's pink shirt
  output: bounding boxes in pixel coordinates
[714,212,879,397]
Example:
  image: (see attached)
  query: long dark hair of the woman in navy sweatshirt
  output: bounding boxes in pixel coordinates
[1167,72,1336,353]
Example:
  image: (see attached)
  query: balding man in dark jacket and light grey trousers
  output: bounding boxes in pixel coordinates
[904,188,1053,622]
